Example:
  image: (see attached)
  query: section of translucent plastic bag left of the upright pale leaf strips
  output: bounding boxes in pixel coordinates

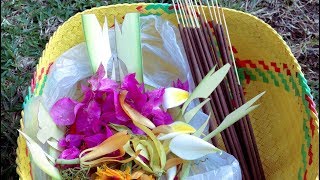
[42,43,93,110]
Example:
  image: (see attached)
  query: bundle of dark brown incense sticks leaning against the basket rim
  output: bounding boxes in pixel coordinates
[173,0,265,180]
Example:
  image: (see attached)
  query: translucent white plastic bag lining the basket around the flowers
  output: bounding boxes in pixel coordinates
[31,15,241,180]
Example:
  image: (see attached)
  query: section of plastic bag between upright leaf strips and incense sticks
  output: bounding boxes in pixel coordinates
[140,15,194,89]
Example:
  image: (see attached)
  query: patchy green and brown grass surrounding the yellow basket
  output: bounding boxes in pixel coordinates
[1,0,319,179]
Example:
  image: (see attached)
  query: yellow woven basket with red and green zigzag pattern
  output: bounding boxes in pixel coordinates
[16,4,319,179]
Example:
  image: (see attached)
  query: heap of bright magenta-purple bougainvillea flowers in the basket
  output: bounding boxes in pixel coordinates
[50,68,178,159]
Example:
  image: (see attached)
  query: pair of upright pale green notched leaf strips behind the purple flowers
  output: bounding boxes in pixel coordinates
[82,13,143,82]
